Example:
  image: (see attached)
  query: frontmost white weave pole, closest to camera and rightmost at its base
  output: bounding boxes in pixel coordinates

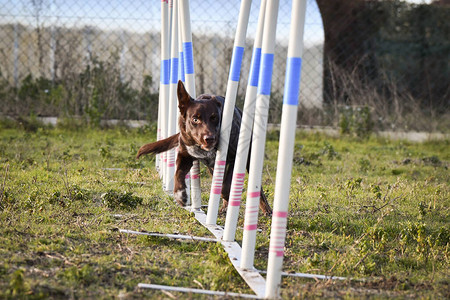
[265,0,306,299]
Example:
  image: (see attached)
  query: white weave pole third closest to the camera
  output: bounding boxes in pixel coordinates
[223,0,266,242]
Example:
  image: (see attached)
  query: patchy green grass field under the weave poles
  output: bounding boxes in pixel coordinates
[0,124,450,299]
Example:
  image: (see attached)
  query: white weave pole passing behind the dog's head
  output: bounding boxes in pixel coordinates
[179,0,202,209]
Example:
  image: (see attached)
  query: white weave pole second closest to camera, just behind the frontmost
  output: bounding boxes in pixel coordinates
[241,0,279,269]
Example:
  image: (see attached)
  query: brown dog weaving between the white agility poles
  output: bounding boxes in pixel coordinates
[137,81,272,215]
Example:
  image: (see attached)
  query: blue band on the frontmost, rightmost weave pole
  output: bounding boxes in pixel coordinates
[283,57,302,106]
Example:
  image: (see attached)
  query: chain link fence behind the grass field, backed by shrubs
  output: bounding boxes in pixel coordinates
[0,0,450,131]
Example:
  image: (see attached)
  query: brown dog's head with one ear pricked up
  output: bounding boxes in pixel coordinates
[177,81,223,151]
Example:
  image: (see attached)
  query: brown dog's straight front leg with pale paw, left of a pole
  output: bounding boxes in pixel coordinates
[173,150,193,206]
